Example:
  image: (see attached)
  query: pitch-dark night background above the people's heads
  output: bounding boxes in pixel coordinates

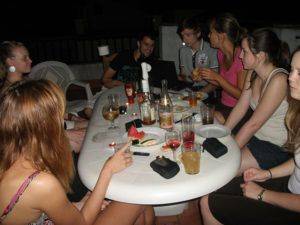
[0,0,300,63]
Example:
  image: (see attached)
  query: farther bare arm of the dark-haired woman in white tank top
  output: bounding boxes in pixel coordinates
[225,71,252,129]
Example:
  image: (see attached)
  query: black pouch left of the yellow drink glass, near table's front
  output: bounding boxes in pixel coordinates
[150,156,180,179]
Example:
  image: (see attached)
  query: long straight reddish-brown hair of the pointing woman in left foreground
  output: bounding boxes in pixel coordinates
[0,80,74,192]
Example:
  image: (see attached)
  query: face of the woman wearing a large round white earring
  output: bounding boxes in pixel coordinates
[9,47,32,74]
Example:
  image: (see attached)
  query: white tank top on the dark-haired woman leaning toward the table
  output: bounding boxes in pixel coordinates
[250,68,288,146]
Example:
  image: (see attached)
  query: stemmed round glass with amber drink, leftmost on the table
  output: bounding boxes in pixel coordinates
[102,94,119,129]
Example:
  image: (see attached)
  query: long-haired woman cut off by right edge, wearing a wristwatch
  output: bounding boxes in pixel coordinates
[201,48,300,225]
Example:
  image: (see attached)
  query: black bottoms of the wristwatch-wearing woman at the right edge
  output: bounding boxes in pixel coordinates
[208,177,300,225]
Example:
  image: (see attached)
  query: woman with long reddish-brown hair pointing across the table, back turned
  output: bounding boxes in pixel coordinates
[0,80,153,225]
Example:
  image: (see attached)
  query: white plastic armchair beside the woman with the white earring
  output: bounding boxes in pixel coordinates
[28,61,100,113]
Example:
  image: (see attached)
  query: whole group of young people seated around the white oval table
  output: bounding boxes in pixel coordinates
[0,13,300,225]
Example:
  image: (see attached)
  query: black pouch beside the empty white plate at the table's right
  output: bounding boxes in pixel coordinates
[202,138,228,158]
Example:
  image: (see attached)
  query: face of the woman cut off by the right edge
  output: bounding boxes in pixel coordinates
[289,51,300,100]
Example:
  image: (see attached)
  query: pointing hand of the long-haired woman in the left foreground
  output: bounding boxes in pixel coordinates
[103,142,132,174]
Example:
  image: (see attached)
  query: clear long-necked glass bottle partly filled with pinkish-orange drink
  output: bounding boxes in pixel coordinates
[158,80,174,131]
